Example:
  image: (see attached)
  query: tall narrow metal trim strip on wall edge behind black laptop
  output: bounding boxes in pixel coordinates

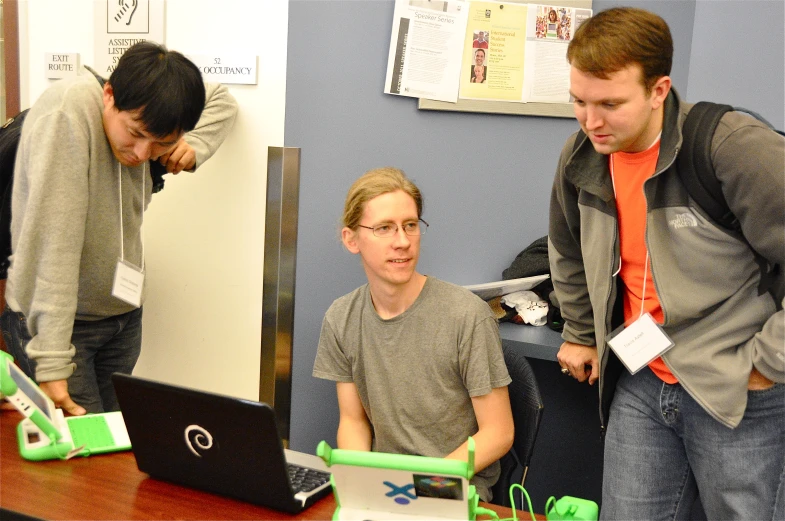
[259,147,300,446]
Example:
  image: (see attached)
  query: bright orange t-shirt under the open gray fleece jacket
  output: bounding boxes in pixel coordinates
[610,140,678,384]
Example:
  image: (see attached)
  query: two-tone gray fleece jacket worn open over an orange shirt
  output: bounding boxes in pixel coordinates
[549,91,785,427]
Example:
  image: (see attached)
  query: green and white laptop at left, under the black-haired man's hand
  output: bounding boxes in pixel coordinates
[0,351,131,461]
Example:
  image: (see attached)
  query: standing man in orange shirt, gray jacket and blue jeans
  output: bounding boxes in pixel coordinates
[549,8,785,520]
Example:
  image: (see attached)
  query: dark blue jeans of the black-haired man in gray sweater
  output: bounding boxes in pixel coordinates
[0,307,142,413]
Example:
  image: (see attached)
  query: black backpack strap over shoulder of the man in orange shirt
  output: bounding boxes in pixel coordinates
[676,101,741,231]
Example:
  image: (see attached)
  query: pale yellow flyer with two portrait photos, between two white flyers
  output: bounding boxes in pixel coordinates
[460,2,528,101]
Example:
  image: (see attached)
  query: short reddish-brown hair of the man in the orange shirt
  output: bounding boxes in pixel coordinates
[567,7,673,92]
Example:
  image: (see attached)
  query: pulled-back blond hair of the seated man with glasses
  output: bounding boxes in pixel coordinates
[342,166,423,230]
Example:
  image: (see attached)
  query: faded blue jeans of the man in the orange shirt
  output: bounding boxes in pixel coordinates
[600,368,785,521]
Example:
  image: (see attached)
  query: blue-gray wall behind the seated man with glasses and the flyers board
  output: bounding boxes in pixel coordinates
[285,0,783,451]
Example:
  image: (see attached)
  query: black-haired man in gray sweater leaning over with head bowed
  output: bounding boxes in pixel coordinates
[0,42,237,414]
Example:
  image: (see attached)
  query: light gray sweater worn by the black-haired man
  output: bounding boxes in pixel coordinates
[6,69,237,382]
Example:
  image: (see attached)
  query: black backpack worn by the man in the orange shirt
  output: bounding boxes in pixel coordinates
[573,101,785,309]
